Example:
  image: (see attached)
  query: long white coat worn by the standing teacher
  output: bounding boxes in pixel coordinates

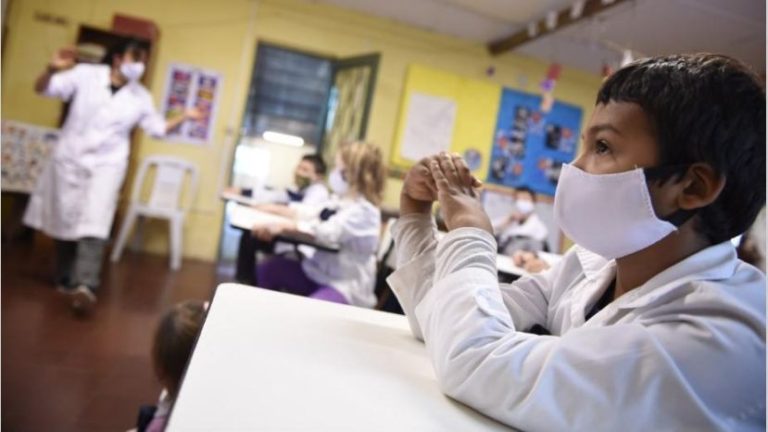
[24,64,166,240]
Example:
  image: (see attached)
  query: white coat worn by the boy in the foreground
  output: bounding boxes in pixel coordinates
[388,215,766,432]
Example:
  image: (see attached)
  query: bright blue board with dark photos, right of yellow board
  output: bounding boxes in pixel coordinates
[488,88,582,195]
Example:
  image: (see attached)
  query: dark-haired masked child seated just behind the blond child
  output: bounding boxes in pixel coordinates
[231,154,329,284]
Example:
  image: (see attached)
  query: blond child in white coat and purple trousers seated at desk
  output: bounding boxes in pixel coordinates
[254,142,384,307]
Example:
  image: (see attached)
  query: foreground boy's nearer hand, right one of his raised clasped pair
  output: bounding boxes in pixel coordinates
[430,153,493,234]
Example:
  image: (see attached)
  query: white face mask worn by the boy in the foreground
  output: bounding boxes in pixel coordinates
[555,164,693,259]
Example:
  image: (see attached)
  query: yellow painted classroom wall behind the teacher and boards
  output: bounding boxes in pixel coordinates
[2,0,600,259]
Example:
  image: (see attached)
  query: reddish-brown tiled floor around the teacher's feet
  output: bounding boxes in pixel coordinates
[0,236,222,432]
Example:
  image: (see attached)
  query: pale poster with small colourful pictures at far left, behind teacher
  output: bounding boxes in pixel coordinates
[1,120,59,193]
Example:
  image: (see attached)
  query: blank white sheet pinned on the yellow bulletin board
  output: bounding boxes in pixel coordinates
[400,92,456,162]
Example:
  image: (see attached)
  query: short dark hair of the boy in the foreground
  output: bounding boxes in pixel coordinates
[597,53,765,244]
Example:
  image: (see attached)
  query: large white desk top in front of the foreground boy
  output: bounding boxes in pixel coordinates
[167,284,510,432]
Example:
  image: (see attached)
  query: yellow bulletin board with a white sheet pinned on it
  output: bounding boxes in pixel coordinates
[390,64,501,178]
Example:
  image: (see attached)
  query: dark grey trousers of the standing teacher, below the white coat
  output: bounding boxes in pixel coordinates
[55,237,107,290]
